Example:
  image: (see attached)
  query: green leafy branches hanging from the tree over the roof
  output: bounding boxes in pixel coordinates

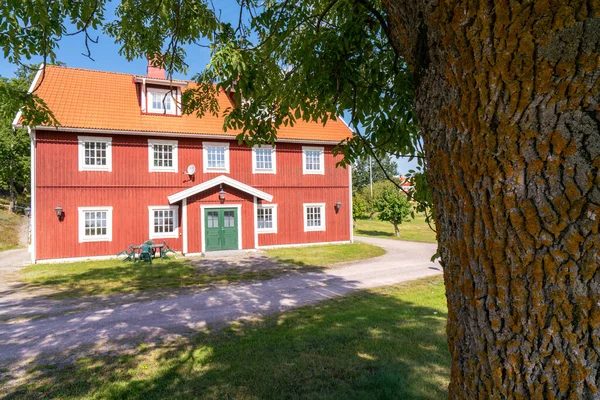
[0,0,430,222]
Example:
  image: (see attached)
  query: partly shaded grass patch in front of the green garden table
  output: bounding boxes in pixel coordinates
[21,260,272,297]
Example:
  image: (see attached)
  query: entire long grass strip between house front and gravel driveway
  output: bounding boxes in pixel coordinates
[21,243,385,297]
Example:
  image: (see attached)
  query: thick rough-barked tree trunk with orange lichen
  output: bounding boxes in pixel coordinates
[384,0,600,399]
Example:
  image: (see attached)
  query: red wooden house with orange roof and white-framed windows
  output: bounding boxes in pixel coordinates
[16,66,352,262]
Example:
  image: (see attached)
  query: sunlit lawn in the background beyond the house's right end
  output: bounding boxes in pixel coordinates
[354,214,436,243]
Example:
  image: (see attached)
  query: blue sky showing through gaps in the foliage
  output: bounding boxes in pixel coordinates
[0,0,416,173]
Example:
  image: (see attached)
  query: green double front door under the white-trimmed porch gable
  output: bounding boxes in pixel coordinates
[204,208,238,251]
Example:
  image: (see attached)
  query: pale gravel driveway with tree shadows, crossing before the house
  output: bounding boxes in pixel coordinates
[0,238,441,364]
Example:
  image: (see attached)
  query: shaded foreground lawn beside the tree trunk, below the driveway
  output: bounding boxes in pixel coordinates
[0,277,450,399]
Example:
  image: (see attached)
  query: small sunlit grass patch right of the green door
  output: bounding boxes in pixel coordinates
[266,243,385,267]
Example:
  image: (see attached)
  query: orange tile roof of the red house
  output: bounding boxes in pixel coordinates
[29,65,351,142]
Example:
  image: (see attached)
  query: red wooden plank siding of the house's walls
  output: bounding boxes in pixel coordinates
[35,130,350,259]
